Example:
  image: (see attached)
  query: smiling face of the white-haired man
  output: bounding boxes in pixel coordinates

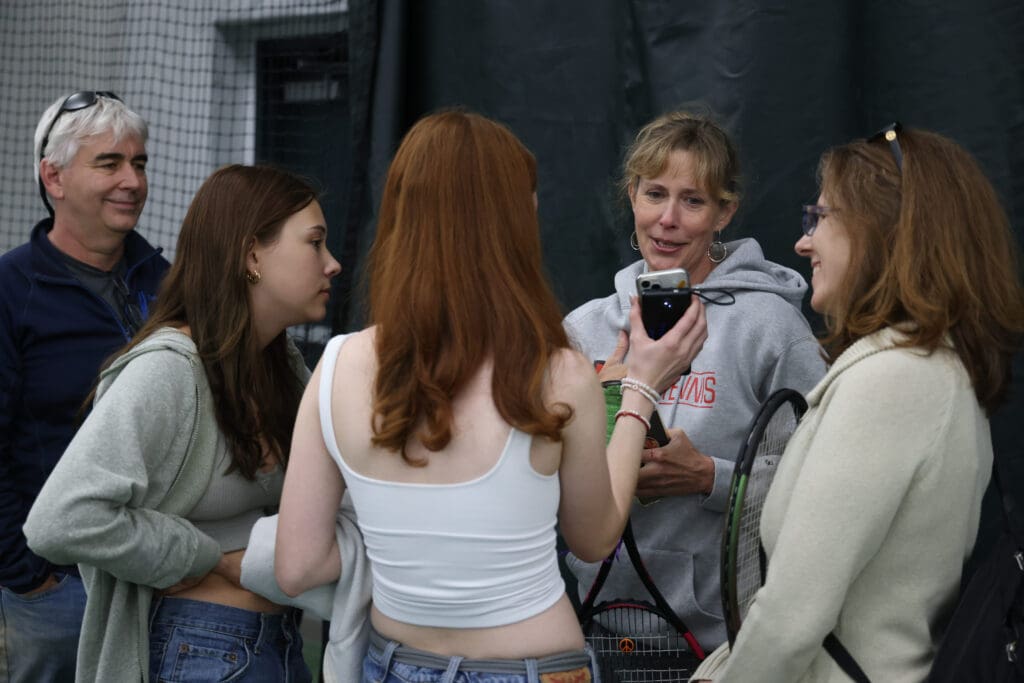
[53,132,148,238]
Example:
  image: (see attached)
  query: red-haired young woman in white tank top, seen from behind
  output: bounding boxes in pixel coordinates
[275,112,706,683]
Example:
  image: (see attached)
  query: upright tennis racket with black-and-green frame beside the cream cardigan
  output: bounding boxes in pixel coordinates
[722,389,807,645]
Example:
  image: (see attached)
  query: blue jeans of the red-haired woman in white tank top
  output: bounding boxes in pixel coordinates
[362,631,600,683]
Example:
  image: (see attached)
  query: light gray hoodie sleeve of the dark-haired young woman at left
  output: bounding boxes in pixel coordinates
[25,351,221,589]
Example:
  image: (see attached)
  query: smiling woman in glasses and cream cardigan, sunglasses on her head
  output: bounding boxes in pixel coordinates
[694,126,1024,682]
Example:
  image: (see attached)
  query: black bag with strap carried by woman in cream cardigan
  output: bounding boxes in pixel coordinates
[823,460,1024,683]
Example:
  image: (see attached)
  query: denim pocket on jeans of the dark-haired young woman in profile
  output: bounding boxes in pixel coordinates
[150,625,251,683]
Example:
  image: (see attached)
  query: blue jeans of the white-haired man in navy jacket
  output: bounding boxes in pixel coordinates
[0,573,85,683]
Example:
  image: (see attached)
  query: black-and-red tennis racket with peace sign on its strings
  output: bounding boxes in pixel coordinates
[579,521,705,683]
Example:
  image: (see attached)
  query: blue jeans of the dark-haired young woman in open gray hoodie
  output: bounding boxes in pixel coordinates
[150,597,312,683]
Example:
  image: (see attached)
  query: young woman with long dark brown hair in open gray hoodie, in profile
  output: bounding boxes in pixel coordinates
[25,165,341,682]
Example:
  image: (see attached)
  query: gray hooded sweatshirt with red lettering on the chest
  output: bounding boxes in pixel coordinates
[564,239,825,652]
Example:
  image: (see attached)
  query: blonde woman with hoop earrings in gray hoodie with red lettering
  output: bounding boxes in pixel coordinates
[565,112,825,651]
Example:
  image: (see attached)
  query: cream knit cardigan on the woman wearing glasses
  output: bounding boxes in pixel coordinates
[692,328,992,683]
